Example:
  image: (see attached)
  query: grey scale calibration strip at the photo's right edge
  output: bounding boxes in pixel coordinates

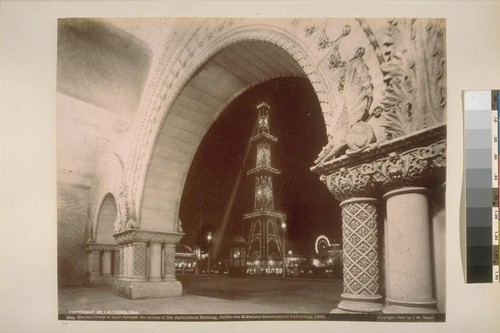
[464,90,500,283]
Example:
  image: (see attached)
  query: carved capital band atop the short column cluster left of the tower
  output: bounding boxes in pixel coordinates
[113,229,184,245]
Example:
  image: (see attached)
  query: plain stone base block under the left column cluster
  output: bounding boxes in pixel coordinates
[113,280,182,299]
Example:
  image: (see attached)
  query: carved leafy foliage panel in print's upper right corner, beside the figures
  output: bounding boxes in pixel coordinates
[380,19,446,140]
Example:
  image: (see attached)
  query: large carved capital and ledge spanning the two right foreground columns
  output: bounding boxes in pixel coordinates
[311,125,446,201]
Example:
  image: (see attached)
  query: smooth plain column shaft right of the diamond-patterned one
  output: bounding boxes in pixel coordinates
[384,187,437,313]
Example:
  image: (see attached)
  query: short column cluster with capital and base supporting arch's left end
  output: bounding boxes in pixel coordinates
[113,229,184,299]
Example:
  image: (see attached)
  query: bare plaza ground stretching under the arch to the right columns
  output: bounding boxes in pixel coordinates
[59,275,342,314]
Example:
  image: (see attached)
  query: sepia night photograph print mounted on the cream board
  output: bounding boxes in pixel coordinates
[56,17,447,322]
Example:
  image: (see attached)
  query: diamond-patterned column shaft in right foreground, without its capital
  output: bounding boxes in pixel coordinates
[338,198,382,313]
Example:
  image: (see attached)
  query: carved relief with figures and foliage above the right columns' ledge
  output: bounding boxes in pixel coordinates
[305,19,446,166]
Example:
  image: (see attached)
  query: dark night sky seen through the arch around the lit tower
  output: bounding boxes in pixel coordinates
[180,78,341,257]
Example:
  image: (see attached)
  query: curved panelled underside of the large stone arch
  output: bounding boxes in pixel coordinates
[140,40,306,231]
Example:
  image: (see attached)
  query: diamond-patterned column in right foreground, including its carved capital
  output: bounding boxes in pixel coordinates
[323,168,383,313]
